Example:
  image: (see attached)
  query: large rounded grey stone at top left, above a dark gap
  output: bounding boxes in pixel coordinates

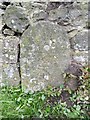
[4,5,29,33]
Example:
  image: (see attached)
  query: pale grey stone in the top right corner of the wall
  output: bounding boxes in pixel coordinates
[68,3,88,27]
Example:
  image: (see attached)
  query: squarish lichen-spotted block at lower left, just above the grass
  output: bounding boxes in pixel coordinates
[2,63,20,86]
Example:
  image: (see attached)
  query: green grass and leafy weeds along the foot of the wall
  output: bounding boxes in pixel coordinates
[0,68,90,120]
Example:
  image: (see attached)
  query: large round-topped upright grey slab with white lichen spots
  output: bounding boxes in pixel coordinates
[21,22,70,91]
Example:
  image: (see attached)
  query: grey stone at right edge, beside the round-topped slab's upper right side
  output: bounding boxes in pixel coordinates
[71,29,88,51]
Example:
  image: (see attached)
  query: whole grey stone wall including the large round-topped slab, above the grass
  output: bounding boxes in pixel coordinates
[0,1,89,92]
